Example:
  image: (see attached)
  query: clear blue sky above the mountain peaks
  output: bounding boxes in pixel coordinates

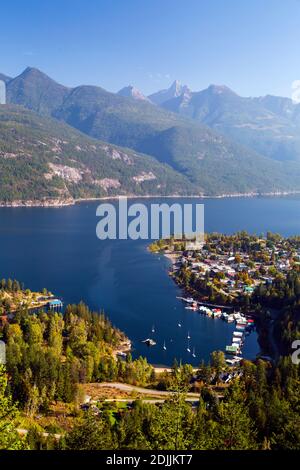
[0,0,300,96]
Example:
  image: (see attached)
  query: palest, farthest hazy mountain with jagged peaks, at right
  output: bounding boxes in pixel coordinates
[162,85,300,161]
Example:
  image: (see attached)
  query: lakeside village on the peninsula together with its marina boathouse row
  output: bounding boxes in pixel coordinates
[150,232,300,365]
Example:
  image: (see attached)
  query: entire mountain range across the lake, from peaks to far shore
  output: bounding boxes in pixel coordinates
[0,68,300,201]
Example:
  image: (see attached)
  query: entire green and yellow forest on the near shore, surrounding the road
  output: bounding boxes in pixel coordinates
[0,272,300,450]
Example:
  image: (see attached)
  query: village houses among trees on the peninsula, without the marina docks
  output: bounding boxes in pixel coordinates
[160,232,300,303]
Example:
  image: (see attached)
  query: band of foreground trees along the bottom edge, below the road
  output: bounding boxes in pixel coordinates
[0,358,300,450]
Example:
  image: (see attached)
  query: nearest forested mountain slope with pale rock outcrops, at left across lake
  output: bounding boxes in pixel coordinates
[0,105,196,203]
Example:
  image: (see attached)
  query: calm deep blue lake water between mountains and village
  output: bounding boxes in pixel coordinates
[0,197,300,365]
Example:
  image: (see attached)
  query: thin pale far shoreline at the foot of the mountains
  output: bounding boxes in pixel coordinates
[0,190,300,208]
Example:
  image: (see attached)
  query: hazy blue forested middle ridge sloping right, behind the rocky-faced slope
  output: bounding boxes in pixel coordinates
[51,86,300,195]
